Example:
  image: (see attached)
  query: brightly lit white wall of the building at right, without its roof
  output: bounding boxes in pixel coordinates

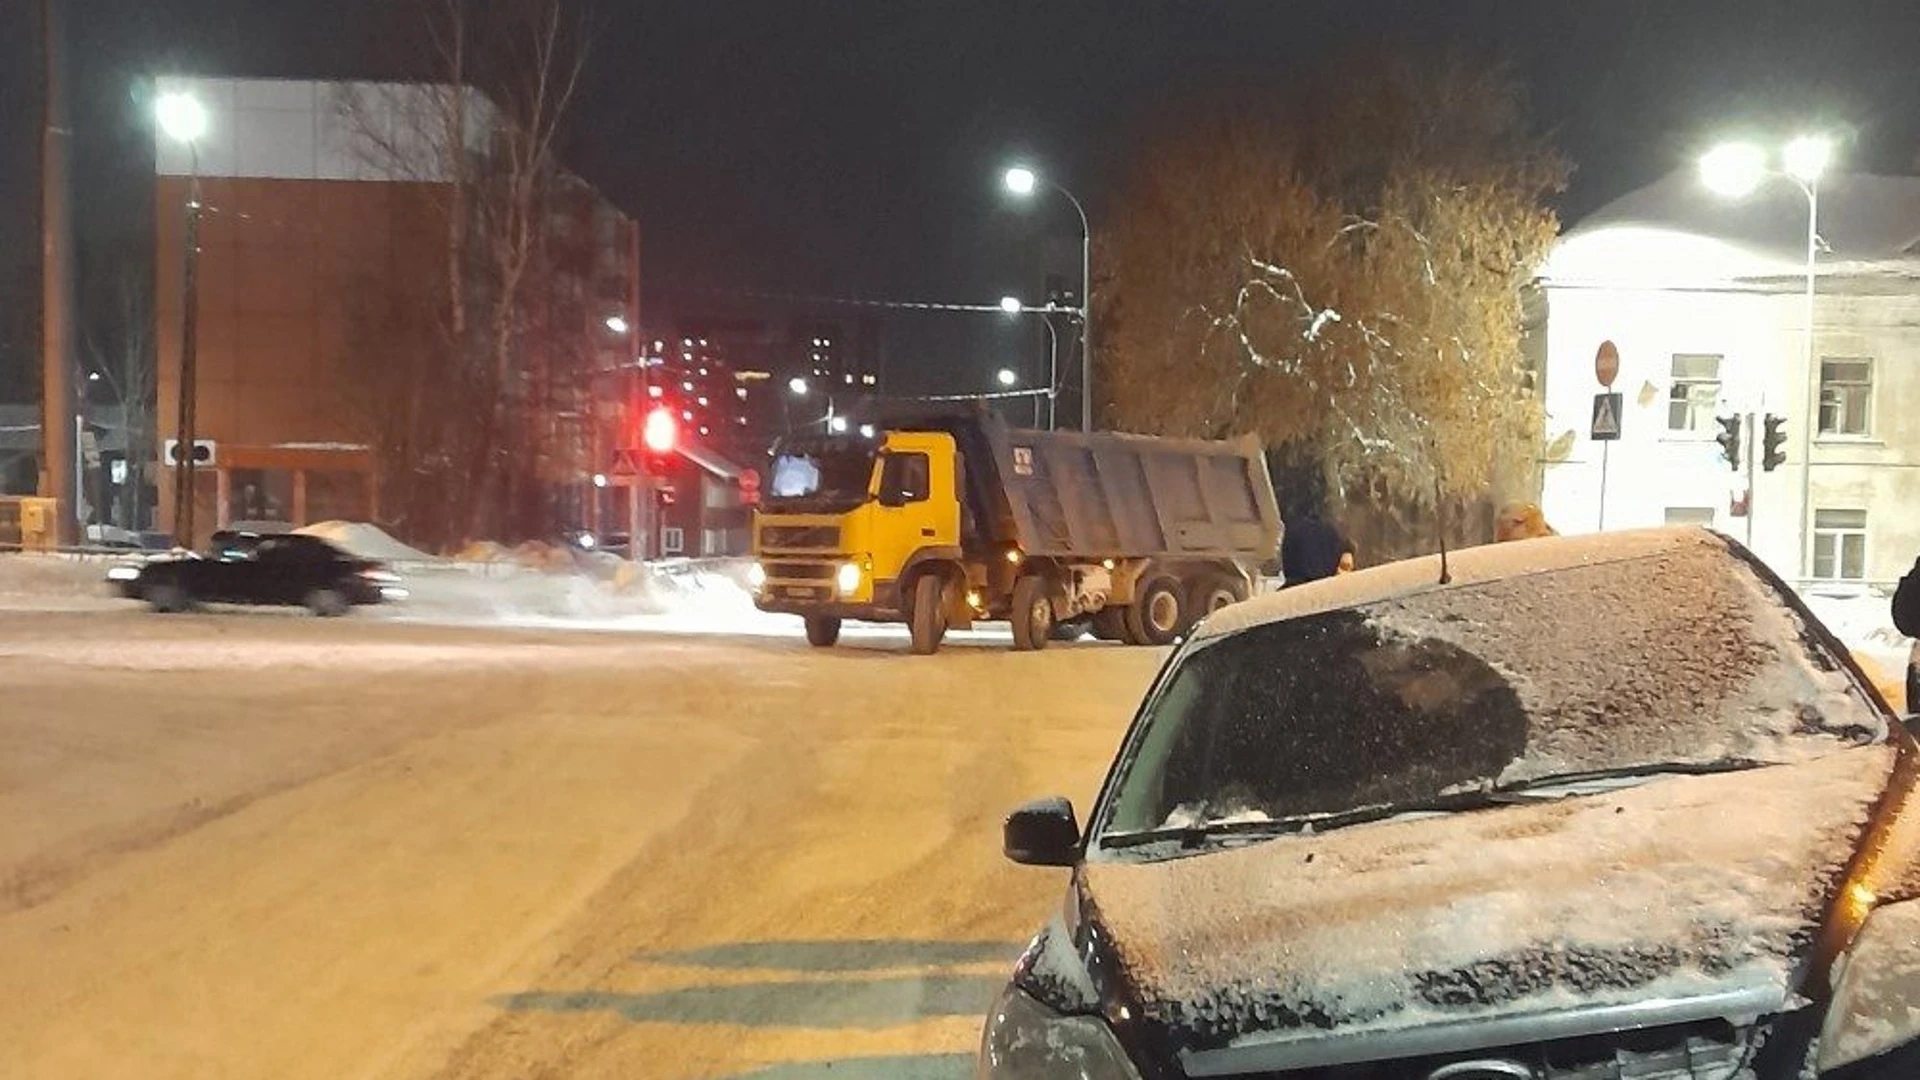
[1542,279,1920,582]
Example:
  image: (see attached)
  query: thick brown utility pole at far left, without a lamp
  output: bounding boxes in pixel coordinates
[40,0,79,546]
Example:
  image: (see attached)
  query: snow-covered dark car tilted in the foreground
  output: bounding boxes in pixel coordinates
[979,530,1920,1080]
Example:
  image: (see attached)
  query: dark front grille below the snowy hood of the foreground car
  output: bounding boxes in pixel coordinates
[1244,1020,1755,1080]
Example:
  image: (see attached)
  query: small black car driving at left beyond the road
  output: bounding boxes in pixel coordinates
[108,532,407,617]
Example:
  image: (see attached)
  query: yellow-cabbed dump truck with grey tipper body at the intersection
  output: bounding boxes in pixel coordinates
[751,409,1281,653]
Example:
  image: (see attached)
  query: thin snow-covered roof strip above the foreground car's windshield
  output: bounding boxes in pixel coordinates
[1192,527,1741,640]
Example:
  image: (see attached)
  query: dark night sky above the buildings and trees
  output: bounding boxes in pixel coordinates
[0,0,1920,394]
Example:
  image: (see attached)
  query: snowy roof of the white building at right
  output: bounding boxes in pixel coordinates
[1544,169,1920,284]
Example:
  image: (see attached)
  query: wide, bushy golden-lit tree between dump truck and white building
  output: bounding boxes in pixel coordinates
[1102,48,1565,553]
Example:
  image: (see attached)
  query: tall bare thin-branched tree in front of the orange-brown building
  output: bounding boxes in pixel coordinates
[336,0,586,542]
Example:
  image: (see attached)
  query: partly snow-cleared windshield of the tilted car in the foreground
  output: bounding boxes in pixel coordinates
[1100,546,1885,846]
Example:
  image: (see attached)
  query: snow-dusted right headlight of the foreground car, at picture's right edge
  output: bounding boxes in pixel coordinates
[1820,886,1920,1076]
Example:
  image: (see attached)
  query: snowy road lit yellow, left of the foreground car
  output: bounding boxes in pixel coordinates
[0,609,1158,1080]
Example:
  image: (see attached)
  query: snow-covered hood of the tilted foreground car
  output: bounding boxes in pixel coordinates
[1079,746,1895,1074]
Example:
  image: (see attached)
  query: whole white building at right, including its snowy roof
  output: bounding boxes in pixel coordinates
[1540,171,1920,584]
